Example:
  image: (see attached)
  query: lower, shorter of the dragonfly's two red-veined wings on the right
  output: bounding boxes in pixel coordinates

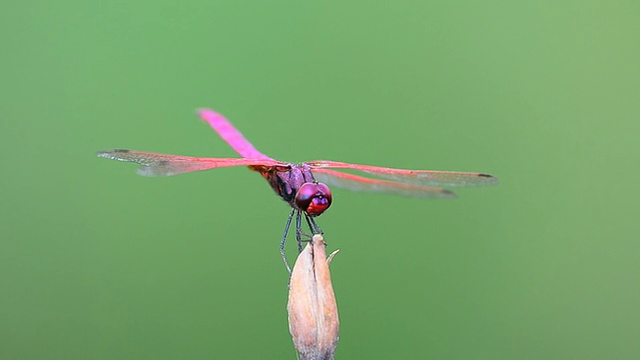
[311,169,456,199]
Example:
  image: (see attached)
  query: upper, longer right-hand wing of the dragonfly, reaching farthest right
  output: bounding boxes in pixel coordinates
[307,160,498,187]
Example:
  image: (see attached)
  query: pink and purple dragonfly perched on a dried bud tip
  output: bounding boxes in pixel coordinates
[97,109,498,272]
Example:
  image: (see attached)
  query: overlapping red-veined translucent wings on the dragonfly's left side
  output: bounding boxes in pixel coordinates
[97,149,288,176]
